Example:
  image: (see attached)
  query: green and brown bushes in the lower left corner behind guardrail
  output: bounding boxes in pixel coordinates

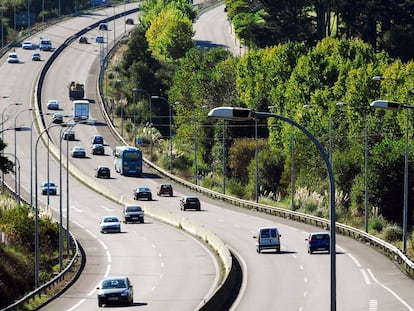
[0,192,59,308]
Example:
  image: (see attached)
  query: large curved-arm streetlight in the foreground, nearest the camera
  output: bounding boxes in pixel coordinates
[208,107,336,311]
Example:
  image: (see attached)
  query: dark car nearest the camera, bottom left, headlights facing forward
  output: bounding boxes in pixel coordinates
[96,276,134,307]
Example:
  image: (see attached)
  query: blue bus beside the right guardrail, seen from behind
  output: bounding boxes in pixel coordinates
[113,146,142,176]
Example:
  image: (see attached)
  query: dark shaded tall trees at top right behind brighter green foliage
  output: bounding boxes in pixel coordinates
[225,0,414,60]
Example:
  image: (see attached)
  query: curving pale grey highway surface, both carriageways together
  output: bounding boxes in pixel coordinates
[0,2,414,311]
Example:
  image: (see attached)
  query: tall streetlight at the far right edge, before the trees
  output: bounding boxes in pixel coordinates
[370,100,414,254]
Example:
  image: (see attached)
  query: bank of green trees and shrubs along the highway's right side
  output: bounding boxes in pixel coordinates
[107,0,414,256]
